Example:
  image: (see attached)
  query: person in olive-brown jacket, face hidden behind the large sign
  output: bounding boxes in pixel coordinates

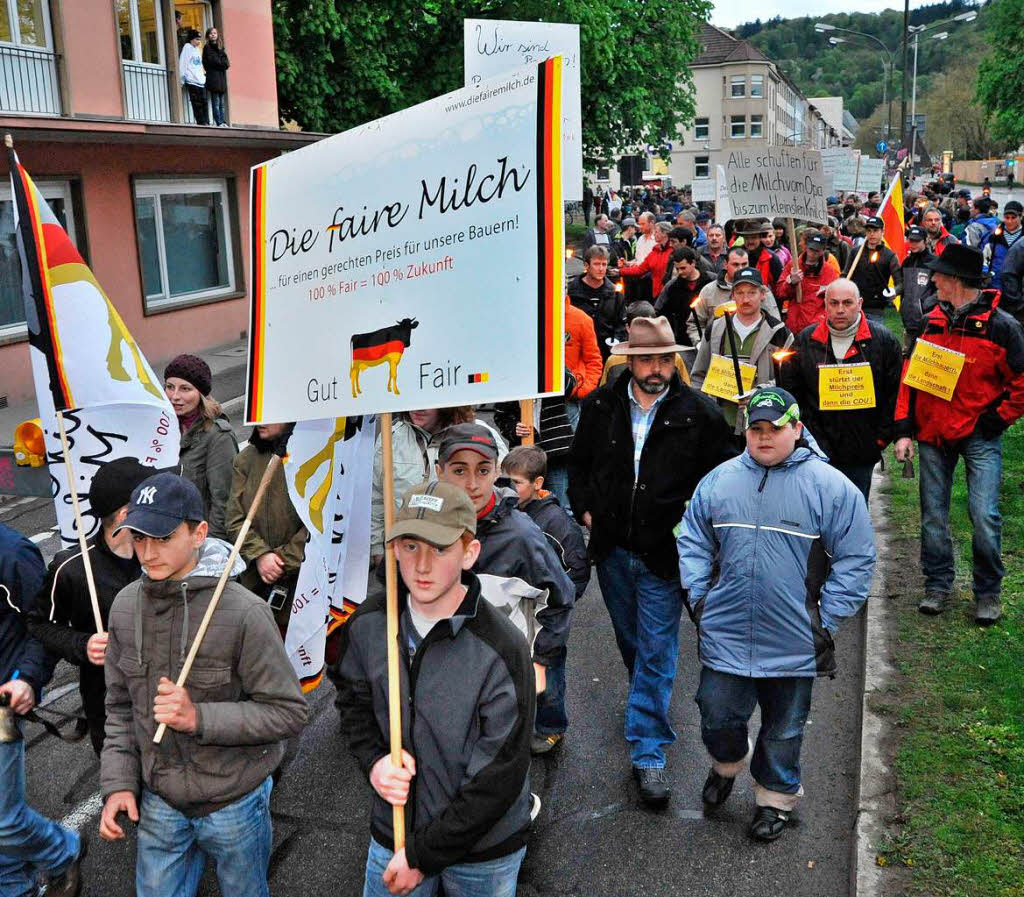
[225,424,306,638]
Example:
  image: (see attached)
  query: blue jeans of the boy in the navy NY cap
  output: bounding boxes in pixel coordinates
[135,776,272,897]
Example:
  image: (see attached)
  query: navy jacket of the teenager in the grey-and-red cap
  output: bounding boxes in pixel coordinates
[473,488,575,667]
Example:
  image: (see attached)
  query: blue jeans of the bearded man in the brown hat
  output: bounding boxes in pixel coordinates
[597,547,683,769]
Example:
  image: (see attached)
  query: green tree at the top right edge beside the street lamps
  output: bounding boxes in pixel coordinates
[978,0,1024,146]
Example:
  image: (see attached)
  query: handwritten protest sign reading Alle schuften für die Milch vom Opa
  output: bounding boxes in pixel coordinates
[725,146,828,223]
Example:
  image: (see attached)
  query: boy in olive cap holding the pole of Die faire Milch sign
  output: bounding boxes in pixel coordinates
[332,482,535,897]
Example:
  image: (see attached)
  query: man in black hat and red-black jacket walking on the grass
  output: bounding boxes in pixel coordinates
[896,244,1024,626]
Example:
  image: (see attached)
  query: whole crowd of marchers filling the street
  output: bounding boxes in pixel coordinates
[6,175,1024,897]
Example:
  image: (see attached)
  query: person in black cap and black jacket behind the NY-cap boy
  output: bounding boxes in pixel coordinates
[29,458,154,757]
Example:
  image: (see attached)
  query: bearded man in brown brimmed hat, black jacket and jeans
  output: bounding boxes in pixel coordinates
[568,316,735,806]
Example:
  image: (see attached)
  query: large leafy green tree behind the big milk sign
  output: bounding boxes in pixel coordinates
[272,0,712,166]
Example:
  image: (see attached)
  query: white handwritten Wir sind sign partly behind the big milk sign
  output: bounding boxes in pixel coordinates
[463,18,583,203]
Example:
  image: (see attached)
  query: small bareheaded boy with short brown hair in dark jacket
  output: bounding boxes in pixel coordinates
[502,445,590,755]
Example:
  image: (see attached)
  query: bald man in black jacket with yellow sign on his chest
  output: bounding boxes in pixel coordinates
[779,277,903,500]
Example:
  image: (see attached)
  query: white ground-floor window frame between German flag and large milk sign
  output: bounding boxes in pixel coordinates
[132,177,237,314]
